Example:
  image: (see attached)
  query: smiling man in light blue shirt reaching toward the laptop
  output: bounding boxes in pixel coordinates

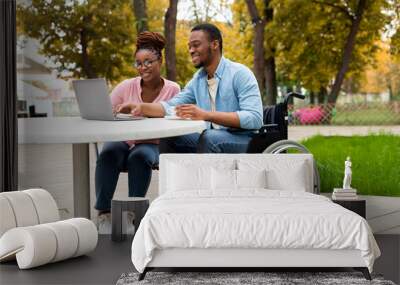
[117,23,262,153]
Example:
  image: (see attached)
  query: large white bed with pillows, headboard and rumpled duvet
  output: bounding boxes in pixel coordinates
[132,154,380,278]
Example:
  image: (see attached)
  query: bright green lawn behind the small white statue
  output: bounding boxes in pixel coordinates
[301,134,400,197]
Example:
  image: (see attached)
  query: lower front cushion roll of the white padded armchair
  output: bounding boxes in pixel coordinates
[0,218,98,269]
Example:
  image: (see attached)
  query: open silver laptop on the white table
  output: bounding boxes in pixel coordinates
[72,78,144,121]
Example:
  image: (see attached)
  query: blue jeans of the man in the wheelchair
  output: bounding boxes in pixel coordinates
[160,129,253,153]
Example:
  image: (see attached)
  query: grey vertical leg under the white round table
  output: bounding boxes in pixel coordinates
[72,143,90,216]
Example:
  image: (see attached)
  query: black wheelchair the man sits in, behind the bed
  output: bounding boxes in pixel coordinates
[246,92,320,194]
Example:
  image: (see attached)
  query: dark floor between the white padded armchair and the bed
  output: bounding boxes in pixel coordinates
[0,235,135,285]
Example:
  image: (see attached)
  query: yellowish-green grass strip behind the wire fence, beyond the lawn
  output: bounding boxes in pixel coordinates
[332,106,400,125]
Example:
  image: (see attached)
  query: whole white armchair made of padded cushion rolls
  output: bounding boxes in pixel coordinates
[0,189,98,269]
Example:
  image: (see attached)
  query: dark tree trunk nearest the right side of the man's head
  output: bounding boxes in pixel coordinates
[246,0,265,97]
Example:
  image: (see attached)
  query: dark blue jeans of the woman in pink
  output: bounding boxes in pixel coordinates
[95,142,159,211]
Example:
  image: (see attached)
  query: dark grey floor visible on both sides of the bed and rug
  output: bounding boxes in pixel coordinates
[0,235,400,285]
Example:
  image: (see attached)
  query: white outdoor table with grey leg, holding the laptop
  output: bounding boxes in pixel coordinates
[18,117,206,218]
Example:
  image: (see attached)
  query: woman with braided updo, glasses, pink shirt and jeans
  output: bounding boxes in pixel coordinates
[95,32,180,234]
